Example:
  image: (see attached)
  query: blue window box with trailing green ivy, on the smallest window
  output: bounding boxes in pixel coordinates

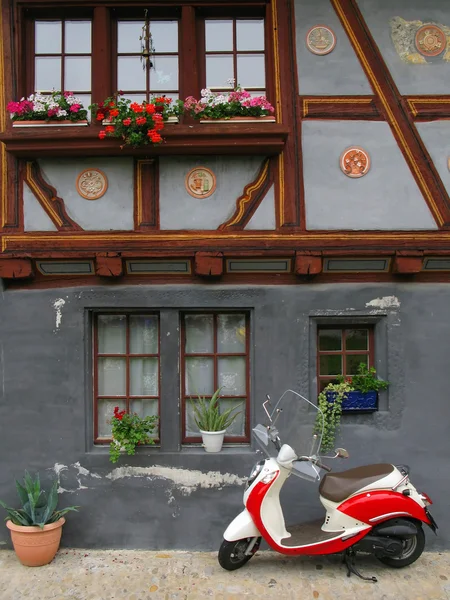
[314,363,389,452]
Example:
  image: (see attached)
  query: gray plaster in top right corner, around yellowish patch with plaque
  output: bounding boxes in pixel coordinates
[357,0,450,94]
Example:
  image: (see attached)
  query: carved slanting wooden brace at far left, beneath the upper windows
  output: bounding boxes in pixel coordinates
[23,161,83,231]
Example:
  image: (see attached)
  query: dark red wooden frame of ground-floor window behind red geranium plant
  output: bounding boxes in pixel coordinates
[92,311,161,444]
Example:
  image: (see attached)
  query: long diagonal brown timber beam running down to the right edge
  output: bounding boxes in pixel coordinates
[331,0,450,227]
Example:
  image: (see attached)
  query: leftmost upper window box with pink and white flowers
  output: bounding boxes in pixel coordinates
[6,91,88,127]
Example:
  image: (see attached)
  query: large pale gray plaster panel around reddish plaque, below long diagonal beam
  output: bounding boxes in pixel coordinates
[302,121,437,230]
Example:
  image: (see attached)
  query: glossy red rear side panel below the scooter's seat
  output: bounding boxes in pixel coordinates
[338,490,430,525]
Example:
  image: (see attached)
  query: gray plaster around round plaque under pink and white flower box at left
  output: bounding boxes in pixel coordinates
[37,157,134,231]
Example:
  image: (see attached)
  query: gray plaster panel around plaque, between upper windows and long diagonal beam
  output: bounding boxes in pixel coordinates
[294,0,373,96]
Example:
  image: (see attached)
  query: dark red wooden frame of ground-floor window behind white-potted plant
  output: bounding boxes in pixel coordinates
[180,310,250,444]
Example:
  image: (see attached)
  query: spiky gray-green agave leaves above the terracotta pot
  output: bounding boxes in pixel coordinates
[0,471,78,529]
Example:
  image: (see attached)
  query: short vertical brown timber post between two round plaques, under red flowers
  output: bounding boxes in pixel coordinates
[134,158,159,231]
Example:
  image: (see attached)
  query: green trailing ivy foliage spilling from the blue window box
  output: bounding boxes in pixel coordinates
[314,363,389,452]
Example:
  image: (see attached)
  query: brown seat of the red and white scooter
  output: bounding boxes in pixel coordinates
[319,463,394,502]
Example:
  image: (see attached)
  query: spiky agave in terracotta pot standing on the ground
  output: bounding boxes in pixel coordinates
[0,471,78,567]
